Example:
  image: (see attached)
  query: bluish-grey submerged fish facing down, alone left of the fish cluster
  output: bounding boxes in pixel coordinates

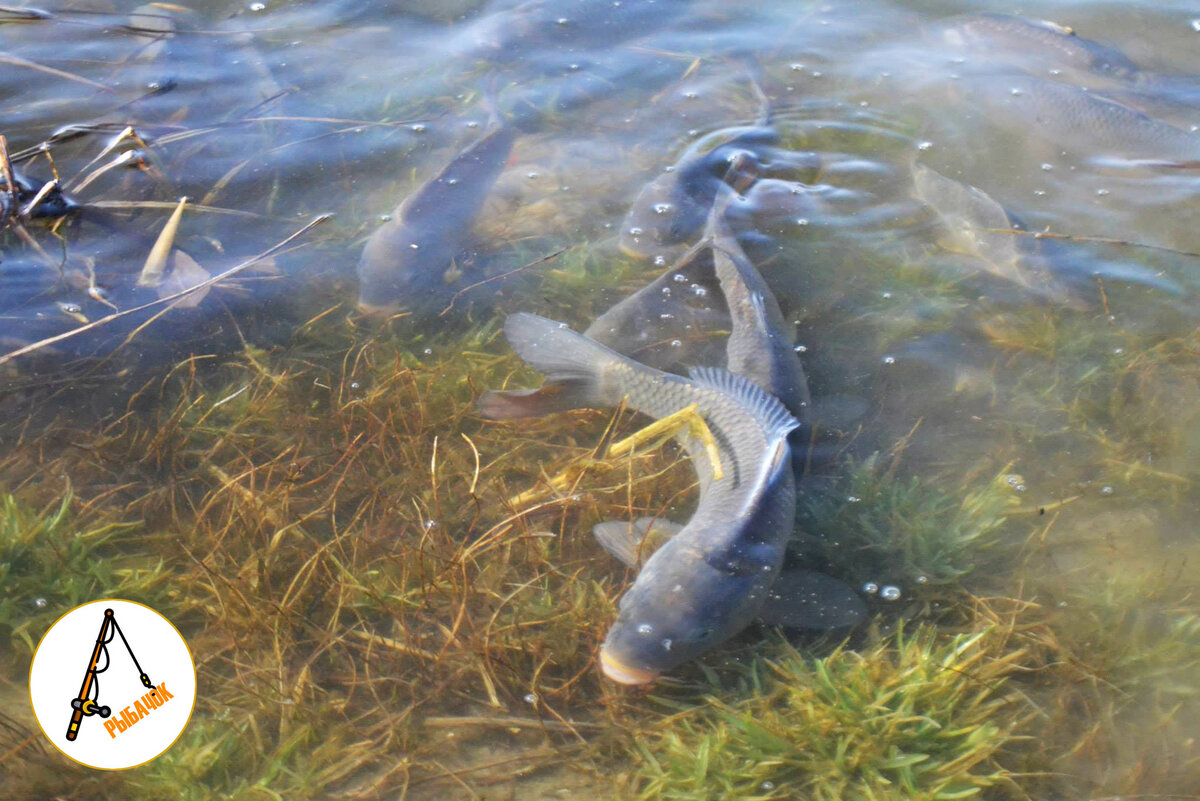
[358,98,516,314]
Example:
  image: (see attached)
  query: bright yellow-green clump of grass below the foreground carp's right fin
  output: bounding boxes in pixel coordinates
[638,627,1030,801]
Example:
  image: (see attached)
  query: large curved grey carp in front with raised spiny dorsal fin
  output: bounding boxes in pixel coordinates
[480,314,798,683]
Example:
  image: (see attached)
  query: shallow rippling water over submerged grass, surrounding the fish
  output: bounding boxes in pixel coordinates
[0,0,1200,799]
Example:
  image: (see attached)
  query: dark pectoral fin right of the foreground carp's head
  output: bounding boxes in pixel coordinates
[758,568,866,631]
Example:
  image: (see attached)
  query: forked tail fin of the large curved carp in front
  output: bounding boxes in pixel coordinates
[479,313,626,418]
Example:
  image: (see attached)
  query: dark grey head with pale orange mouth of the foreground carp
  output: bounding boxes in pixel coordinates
[600,532,781,685]
